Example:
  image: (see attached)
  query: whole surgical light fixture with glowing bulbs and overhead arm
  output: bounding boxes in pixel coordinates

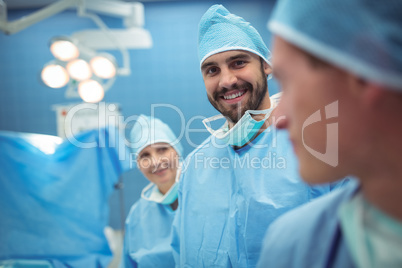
[19,0,152,102]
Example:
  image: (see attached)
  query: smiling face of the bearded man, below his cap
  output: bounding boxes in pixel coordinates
[201,50,271,123]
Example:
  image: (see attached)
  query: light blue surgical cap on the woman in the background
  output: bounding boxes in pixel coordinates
[130,114,183,157]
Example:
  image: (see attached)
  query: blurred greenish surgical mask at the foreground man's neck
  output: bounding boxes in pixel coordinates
[339,193,402,268]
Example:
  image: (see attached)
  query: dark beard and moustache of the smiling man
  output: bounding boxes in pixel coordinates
[208,68,268,124]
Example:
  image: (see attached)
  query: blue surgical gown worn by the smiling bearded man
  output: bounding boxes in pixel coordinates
[172,127,342,267]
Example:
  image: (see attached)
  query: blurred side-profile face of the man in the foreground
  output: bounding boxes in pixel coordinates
[272,37,362,183]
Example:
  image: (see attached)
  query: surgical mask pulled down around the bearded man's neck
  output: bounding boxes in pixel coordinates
[202,105,274,147]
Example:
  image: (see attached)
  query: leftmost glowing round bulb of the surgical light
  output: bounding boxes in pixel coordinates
[41,63,70,88]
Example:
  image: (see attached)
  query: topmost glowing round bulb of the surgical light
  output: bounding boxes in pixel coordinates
[50,37,80,61]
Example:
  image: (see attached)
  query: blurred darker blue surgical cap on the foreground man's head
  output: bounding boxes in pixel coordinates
[268,0,402,90]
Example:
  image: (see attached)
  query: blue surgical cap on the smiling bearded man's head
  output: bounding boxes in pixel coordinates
[198,5,271,66]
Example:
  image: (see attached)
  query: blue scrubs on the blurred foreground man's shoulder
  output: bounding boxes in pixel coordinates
[258,182,358,268]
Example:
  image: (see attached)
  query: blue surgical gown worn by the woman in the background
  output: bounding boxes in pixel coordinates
[120,198,175,268]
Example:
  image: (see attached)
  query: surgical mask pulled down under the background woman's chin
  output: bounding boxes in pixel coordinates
[141,165,181,205]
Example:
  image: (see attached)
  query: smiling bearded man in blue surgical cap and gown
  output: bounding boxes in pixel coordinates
[172,5,346,267]
